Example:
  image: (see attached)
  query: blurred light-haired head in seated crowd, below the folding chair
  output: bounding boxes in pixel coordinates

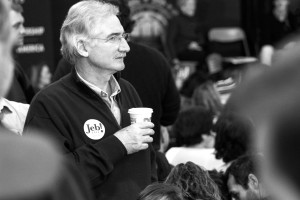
[192,81,222,115]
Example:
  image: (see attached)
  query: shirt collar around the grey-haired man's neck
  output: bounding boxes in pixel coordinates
[76,71,121,98]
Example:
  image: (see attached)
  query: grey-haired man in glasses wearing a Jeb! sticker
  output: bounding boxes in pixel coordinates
[24,1,155,200]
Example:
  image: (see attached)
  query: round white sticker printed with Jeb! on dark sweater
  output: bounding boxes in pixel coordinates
[83,119,105,140]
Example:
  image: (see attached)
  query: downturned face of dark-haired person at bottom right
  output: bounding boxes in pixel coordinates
[227,175,259,200]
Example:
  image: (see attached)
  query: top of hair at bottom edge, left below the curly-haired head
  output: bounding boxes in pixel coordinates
[137,183,184,200]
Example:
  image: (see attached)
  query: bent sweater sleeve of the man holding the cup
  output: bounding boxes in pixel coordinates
[23,101,127,186]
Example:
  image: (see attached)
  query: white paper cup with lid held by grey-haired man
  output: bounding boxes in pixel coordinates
[128,108,153,124]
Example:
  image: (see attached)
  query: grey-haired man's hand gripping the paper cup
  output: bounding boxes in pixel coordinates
[114,122,154,154]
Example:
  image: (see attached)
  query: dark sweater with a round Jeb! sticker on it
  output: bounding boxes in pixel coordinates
[24,70,155,200]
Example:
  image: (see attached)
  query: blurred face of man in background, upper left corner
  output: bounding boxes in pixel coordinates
[9,10,25,46]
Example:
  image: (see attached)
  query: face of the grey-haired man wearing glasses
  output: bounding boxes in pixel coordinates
[88,15,130,72]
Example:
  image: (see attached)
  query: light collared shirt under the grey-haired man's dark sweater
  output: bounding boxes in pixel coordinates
[76,71,121,125]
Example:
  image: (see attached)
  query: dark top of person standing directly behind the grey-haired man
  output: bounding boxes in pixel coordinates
[53,42,180,149]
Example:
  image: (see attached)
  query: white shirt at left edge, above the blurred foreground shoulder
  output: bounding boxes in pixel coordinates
[0,98,29,135]
